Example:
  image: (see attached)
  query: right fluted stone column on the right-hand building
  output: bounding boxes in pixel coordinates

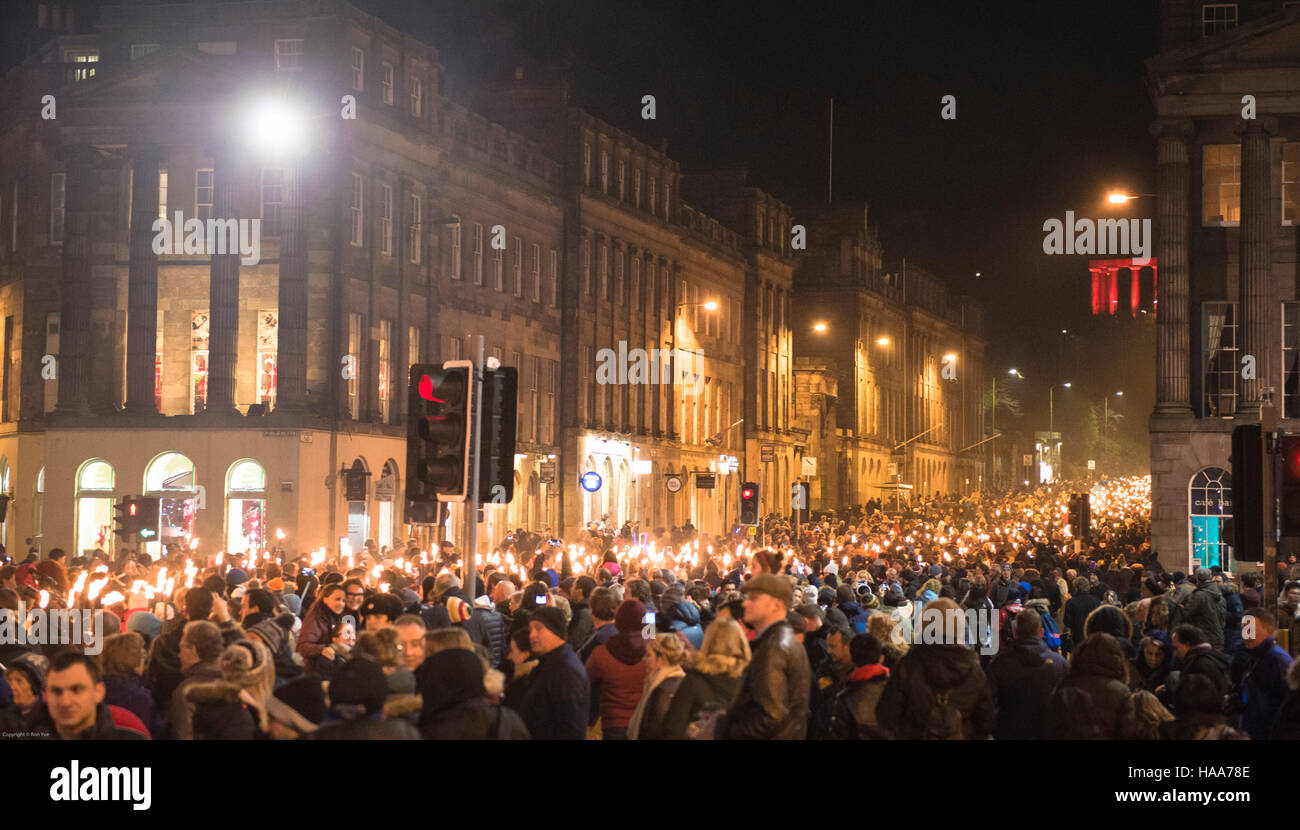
[1236,117,1277,420]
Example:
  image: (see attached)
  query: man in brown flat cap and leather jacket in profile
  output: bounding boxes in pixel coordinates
[720,574,813,740]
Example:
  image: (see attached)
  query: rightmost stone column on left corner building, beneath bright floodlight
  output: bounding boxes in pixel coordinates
[276,160,309,412]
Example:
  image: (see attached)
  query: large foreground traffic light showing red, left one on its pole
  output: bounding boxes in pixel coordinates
[407,360,473,502]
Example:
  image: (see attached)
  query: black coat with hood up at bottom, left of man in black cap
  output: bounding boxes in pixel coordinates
[417,648,528,740]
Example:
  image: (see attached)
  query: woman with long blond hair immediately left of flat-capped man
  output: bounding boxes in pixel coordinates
[663,617,753,739]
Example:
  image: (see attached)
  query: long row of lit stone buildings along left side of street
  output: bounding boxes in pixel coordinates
[0,0,977,552]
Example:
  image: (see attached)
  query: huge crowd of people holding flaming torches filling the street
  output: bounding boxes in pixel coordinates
[0,479,1300,740]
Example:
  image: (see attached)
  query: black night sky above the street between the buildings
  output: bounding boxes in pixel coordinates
[0,0,1158,455]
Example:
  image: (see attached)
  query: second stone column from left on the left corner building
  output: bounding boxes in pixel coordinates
[126,143,163,415]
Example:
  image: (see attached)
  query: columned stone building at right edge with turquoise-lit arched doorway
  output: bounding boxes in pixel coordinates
[1147,0,1300,570]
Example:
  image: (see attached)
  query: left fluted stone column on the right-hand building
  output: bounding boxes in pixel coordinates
[1152,118,1192,418]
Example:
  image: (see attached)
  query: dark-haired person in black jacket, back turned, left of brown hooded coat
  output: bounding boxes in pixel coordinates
[988,608,1069,740]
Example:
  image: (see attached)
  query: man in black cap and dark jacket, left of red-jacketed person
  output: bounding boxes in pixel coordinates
[519,605,592,740]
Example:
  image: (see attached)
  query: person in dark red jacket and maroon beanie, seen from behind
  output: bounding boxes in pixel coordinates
[586,600,653,740]
